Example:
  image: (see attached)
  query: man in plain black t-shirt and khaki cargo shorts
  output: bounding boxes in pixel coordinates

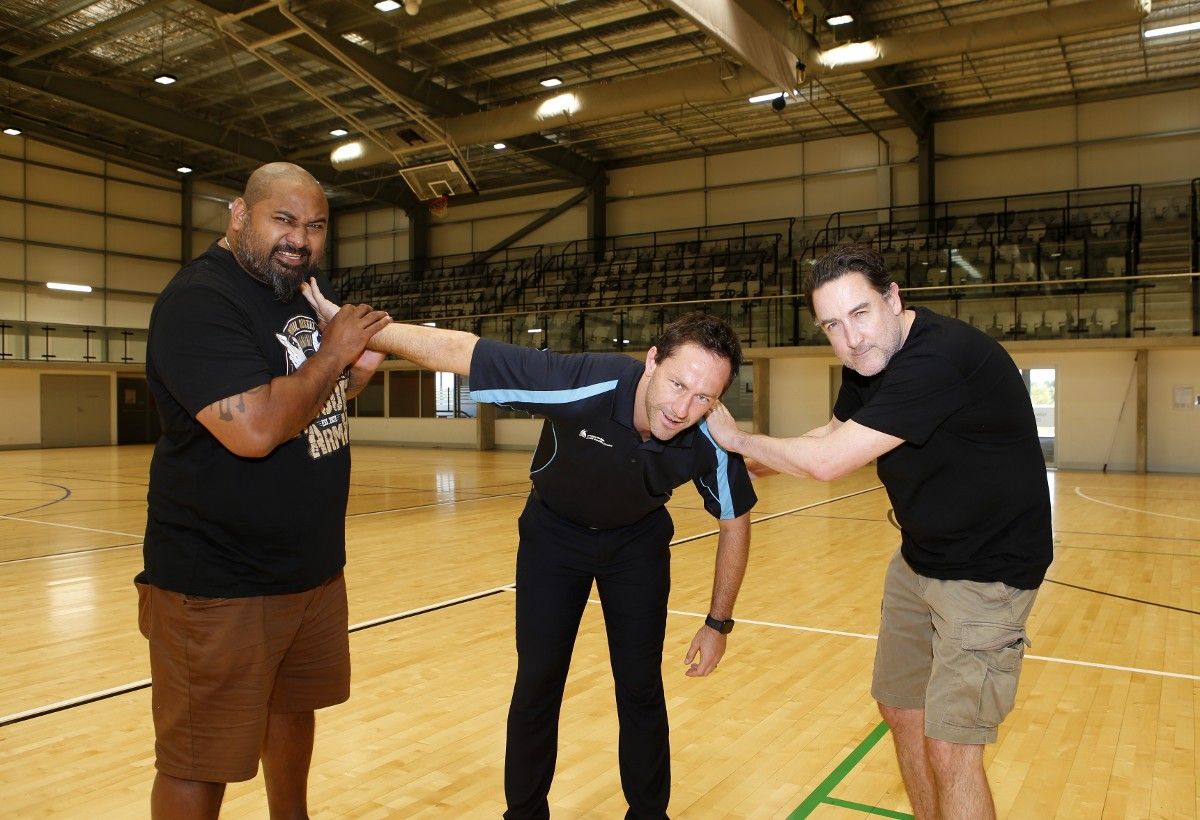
[708,245,1052,819]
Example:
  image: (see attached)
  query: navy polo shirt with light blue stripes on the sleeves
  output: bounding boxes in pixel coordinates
[470,339,757,529]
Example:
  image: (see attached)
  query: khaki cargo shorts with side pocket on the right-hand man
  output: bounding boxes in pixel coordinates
[871,550,1038,744]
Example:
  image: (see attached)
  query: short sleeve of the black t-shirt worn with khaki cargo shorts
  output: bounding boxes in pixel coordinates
[859,351,971,445]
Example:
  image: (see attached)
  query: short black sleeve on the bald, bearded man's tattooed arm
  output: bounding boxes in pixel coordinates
[149,287,272,417]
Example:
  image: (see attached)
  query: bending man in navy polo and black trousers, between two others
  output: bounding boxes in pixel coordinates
[306,283,757,820]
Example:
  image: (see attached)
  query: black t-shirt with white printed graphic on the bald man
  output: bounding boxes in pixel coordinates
[143,244,350,598]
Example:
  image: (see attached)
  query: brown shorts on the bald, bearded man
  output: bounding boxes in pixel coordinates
[137,573,350,783]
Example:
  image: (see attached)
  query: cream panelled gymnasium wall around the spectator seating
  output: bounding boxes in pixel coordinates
[0,90,1200,472]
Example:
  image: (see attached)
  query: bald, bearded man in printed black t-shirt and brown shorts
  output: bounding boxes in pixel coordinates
[137,162,389,820]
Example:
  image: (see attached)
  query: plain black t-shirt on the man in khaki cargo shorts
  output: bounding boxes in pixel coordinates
[834,307,1054,589]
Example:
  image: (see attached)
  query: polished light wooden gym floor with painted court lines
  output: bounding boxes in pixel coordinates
[0,447,1200,820]
